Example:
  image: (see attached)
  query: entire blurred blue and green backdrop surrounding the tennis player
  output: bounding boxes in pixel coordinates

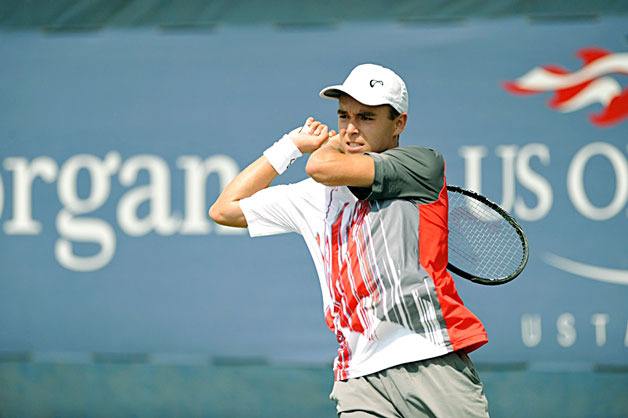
[0,0,628,418]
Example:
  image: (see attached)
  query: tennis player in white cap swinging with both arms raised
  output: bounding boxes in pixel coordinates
[210,64,488,418]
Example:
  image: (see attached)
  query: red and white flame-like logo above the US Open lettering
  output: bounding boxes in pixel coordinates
[504,48,628,126]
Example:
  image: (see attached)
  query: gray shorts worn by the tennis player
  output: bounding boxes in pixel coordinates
[329,352,488,418]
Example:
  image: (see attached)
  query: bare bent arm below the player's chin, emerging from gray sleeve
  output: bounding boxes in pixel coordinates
[305,145,375,187]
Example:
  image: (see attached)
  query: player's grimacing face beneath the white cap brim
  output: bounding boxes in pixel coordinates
[338,95,407,153]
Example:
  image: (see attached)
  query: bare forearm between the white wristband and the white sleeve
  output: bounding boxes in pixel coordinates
[209,156,278,228]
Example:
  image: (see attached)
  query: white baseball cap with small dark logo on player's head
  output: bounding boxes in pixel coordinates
[318,64,408,113]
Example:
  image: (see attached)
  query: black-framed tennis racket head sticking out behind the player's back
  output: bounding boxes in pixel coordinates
[447,185,528,285]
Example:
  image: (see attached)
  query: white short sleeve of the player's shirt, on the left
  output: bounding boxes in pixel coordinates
[240,179,324,237]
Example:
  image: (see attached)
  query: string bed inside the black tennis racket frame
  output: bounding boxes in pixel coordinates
[448,193,524,280]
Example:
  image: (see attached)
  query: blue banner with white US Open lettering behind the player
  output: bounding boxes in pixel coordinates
[0,18,628,365]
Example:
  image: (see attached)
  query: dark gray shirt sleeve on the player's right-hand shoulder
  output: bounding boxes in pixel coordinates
[349,146,445,203]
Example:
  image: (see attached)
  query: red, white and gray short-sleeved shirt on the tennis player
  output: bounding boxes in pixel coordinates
[240,147,488,380]
